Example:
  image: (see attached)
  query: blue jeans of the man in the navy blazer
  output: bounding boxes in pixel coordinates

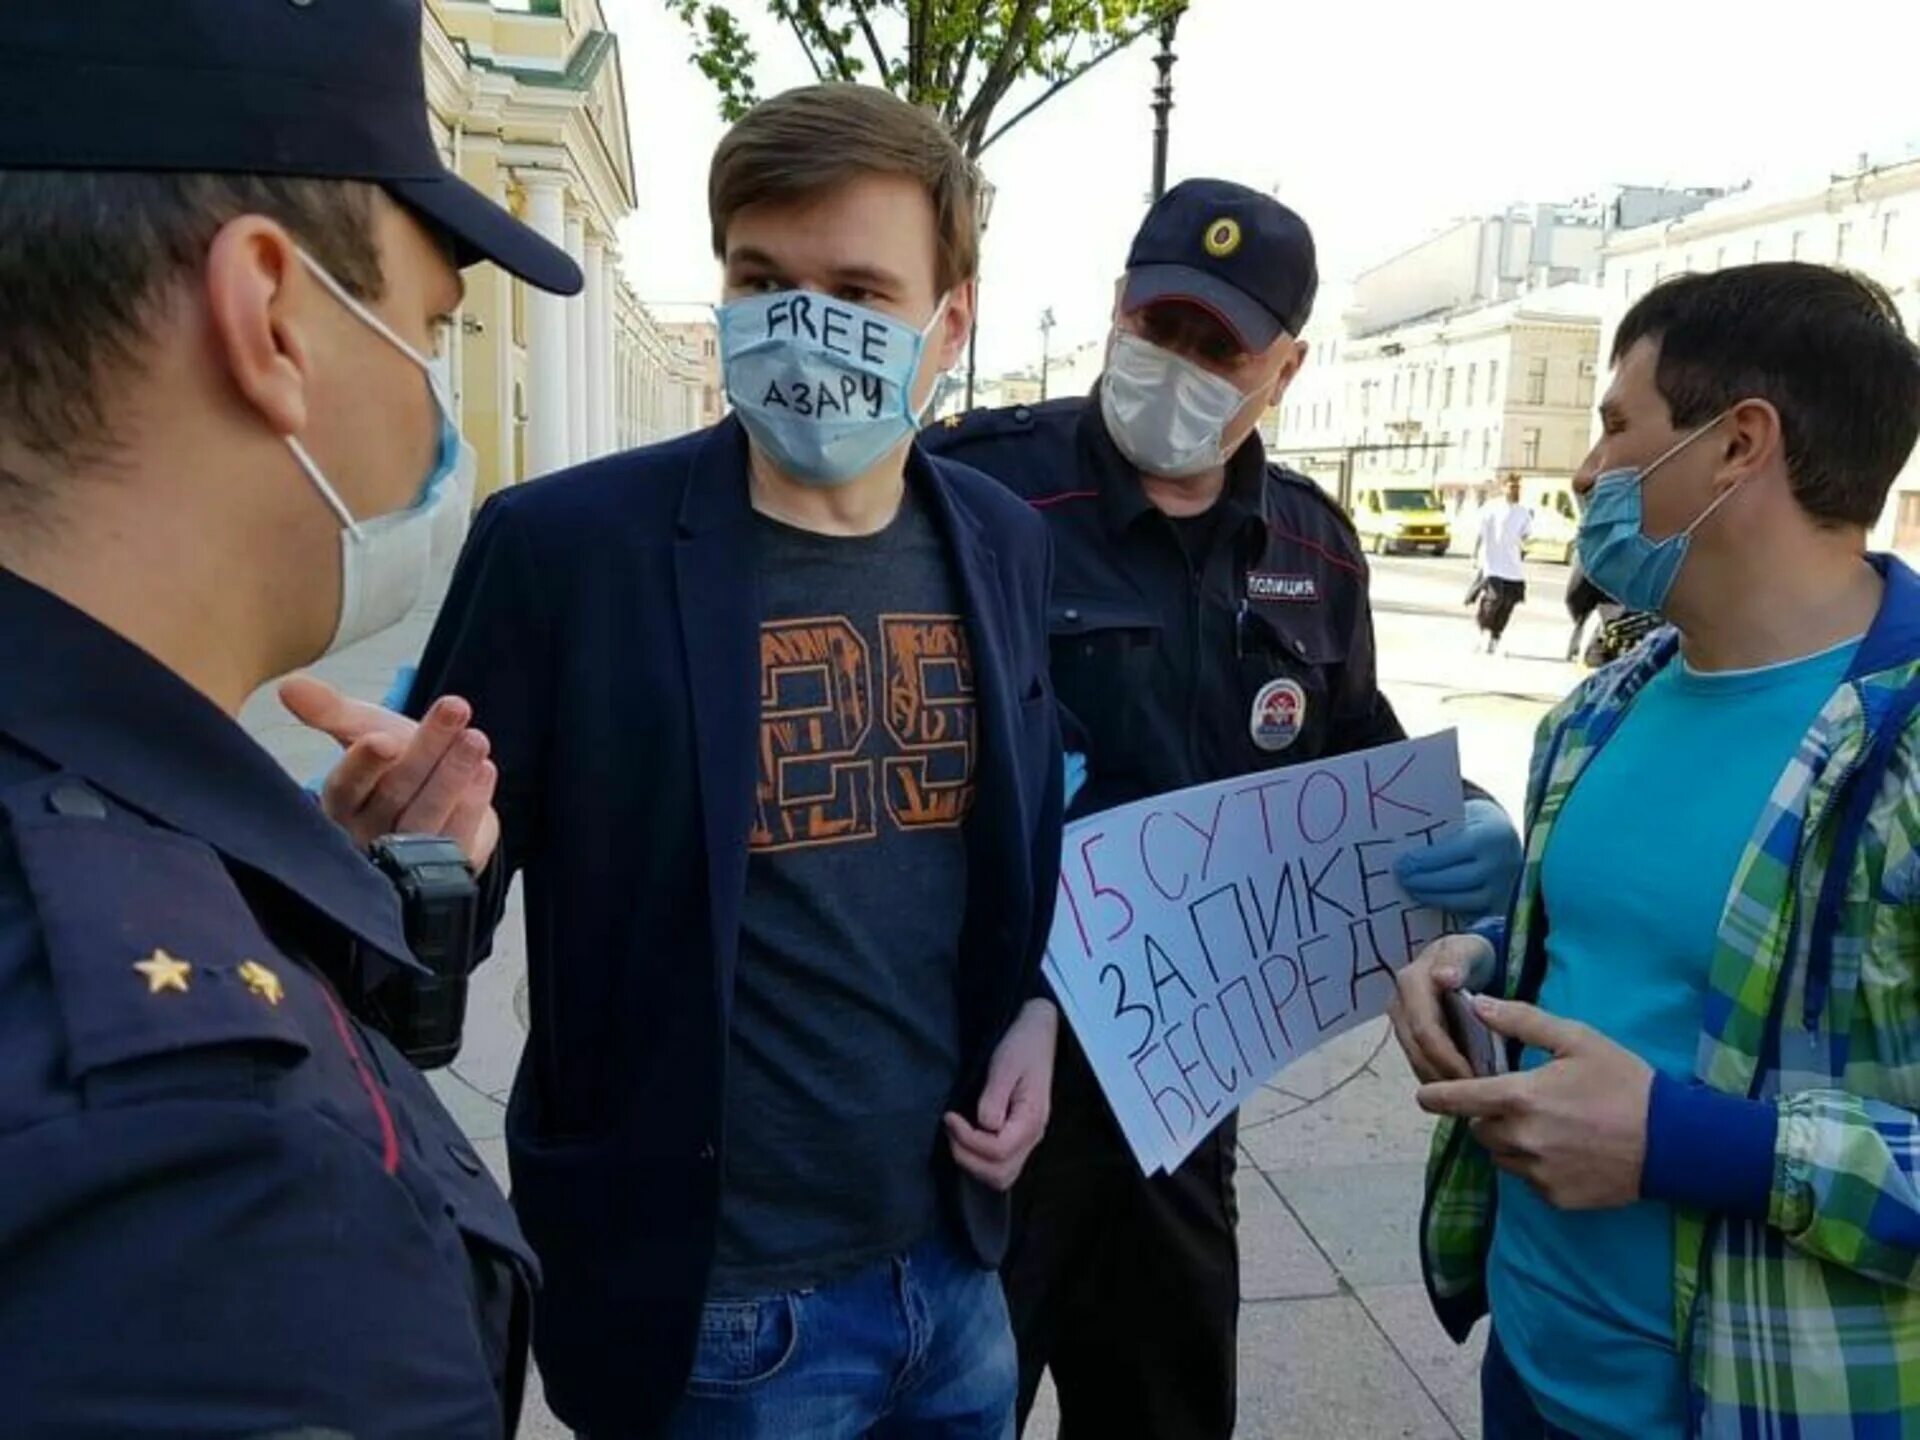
[664,1238,1020,1440]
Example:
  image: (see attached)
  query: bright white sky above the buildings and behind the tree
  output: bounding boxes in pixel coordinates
[603,0,1920,374]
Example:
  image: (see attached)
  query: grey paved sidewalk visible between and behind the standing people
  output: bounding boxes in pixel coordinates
[244,579,1574,1440]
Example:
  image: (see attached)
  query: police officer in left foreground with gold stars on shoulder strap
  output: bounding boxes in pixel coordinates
[0,0,580,1440]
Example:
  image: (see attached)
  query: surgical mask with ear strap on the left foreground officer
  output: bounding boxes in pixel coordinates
[286,252,478,655]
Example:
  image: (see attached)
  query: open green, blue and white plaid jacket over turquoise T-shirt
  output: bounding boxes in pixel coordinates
[1421,557,1920,1440]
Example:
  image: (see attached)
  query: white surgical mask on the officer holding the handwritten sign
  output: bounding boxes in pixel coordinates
[1100,330,1246,480]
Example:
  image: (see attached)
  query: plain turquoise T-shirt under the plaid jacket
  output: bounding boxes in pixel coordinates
[1488,639,1859,1440]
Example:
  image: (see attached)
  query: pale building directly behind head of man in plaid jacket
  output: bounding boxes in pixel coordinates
[1599,154,1920,555]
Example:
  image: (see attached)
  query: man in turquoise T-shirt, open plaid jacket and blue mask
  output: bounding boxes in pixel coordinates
[1394,265,1920,1440]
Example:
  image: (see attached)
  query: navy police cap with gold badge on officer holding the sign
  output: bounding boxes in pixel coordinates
[1121,180,1319,349]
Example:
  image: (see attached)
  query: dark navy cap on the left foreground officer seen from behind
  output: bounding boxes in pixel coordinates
[0,0,582,296]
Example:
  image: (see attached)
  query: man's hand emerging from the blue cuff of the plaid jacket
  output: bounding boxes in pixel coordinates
[1419,996,1653,1210]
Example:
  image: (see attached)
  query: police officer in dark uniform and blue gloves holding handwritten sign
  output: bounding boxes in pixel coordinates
[927,180,1519,1440]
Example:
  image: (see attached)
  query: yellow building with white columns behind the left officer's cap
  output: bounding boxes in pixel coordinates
[424,0,699,495]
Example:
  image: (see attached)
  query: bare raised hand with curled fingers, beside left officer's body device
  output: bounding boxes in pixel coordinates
[280,676,499,872]
